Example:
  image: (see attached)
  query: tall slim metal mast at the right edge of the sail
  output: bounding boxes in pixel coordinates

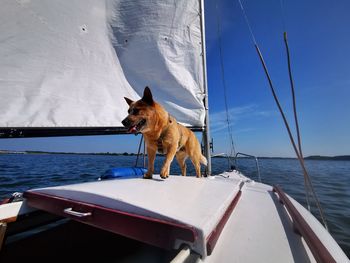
[199,0,211,176]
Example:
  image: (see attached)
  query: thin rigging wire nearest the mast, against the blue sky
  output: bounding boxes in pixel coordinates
[215,1,236,159]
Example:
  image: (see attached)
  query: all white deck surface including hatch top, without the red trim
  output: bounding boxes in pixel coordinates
[9,172,349,263]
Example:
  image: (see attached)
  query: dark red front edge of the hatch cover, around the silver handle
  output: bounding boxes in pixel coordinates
[23,192,197,249]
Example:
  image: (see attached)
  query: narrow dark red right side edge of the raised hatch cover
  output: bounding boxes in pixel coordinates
[207,190,242,256]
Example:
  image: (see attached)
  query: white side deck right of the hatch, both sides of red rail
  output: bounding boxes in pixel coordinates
[204,174,350,263]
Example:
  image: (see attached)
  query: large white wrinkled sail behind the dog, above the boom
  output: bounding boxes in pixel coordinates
[0,0,204,127]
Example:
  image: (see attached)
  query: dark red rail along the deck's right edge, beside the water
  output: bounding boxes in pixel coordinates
[273,186,336,263]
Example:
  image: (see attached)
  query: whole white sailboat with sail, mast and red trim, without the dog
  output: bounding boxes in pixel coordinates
[0,0,349,262]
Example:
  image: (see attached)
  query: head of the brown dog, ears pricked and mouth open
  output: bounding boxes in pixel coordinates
[122,87,155,133]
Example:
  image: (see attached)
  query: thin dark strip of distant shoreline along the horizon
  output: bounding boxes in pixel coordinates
[0,150,350,161]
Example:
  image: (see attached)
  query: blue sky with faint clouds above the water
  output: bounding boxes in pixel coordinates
[0,0,350,157]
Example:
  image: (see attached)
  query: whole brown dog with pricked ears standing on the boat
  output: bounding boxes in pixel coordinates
[122,87,207,179]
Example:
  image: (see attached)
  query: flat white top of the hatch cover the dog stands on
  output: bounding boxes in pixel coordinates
[25,173,241,257]
